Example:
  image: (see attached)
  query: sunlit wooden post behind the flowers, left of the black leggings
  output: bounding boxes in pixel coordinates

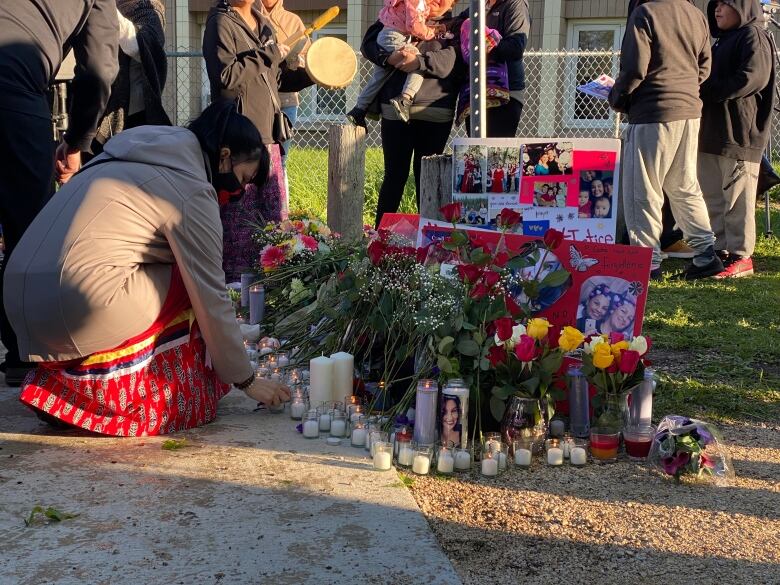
[328,124,366,239]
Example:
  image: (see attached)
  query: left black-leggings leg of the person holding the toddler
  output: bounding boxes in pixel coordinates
[375,118,414,226]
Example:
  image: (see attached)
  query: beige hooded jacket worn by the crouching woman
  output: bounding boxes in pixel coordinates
[4,126,252,383]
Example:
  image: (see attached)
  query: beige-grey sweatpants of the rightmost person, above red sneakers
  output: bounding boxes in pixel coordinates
[698,152,761,257]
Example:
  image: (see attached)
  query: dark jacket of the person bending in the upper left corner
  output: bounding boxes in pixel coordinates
[0,0,119,150]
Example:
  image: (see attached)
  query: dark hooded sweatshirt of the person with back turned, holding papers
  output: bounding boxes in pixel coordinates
[609,0,710,124]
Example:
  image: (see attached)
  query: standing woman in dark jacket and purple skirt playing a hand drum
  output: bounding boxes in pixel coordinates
[203,0,314,282]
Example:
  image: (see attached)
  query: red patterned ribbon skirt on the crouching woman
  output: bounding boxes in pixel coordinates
[20,269,230,437]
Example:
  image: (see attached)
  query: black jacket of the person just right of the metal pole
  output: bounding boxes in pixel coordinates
[459,0,531,91]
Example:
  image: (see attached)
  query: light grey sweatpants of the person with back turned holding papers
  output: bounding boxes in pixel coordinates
[620,118,715,268]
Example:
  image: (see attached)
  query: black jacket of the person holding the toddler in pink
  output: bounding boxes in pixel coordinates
[360,19,465,114]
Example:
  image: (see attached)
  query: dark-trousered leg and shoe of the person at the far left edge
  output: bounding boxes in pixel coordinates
[0,106,54,378]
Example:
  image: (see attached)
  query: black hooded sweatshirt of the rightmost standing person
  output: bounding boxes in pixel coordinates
[699,0,775,163]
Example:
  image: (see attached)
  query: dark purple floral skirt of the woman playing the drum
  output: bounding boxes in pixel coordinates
[220,144,288,282]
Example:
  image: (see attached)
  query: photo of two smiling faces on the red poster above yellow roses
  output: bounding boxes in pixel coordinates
[577,276,636,339]
